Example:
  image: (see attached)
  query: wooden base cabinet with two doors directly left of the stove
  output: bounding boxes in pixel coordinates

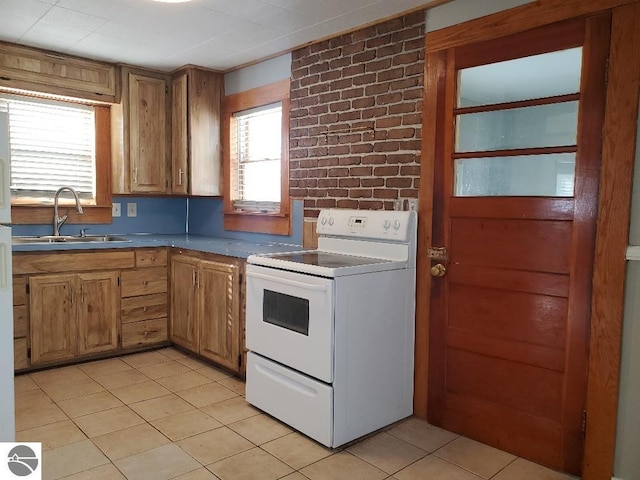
[170,250,242,372]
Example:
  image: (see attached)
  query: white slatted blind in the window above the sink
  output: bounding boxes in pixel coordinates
[0,95,96,199]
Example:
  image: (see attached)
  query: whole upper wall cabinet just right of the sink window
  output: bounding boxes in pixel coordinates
[111,67,170,194]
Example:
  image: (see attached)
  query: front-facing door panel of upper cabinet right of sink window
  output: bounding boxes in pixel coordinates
[129,73,167,193]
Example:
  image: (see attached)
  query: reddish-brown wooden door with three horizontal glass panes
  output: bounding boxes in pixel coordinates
[424,15,610,473]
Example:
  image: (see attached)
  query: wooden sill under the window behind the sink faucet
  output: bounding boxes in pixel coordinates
[11,205,112,225]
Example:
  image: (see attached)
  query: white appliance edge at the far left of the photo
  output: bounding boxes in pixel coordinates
[0,111,15,442]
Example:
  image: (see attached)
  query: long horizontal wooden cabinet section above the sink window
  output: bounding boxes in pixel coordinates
[0,43,117,103]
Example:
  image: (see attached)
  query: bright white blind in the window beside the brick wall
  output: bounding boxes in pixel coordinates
[232,102,282,212]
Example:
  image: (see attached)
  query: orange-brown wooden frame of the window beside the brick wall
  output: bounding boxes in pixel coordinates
[222,78,291,235]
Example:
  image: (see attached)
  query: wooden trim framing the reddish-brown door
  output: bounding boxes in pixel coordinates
[414,0,640,480]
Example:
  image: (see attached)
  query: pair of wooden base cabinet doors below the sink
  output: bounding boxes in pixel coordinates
[29,272,120,365]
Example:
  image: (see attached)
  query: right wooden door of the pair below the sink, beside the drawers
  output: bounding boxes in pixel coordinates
[78,272,120,355]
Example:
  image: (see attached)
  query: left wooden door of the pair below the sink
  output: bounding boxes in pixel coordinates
[29,275,77,365]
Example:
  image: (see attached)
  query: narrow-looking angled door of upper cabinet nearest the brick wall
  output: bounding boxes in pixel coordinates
[171,73,189,194]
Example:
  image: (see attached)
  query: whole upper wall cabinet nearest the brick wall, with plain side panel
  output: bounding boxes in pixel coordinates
[171,67,223,196]
